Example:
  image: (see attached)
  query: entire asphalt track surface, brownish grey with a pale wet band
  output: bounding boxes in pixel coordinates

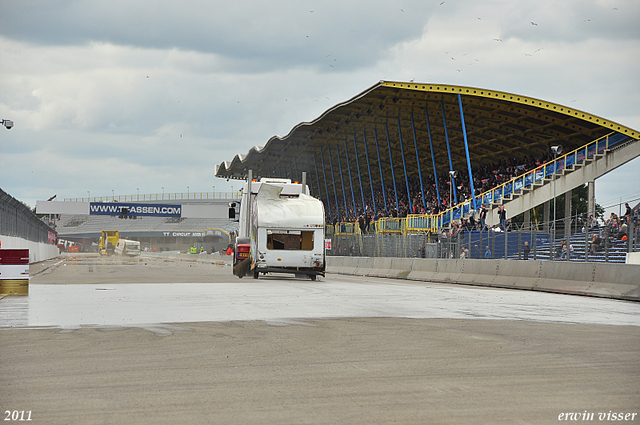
[0,255,640,424]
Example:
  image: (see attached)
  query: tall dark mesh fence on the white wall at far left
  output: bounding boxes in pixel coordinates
[0,189,56,243]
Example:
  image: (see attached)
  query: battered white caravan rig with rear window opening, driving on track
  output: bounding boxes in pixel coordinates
[233,173,325,280]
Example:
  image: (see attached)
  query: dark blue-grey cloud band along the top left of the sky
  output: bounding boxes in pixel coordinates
[0,0,434,72]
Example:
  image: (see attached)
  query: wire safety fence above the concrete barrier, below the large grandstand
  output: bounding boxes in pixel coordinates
[327,214,640,263]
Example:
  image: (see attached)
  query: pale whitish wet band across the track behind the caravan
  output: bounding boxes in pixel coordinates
[0,275,640,328]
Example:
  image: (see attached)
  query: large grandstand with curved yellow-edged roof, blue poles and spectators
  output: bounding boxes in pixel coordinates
[216,81,640,238]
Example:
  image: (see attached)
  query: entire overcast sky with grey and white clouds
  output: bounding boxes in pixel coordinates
[0,0,640,214]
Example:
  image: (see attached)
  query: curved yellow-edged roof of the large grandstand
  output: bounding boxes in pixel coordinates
[216,81,640,180]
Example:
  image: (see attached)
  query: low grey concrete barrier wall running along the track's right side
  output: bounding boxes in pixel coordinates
[327,257,640,301]
